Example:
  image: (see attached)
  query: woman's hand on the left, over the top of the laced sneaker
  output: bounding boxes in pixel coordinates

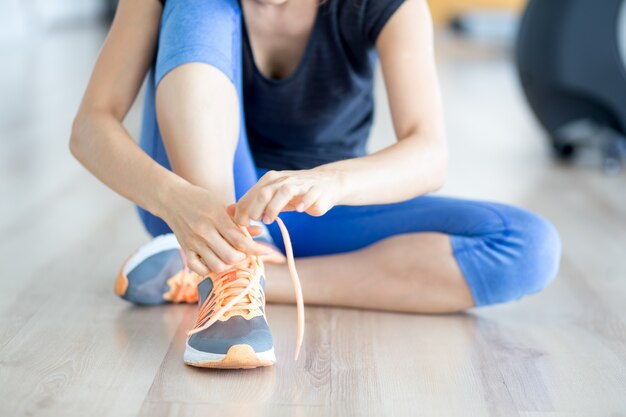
[161,184,272,276]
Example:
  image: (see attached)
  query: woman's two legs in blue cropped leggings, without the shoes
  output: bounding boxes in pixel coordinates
[142,3,560,313]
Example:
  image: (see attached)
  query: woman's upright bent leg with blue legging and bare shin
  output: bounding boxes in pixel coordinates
[139,0,257,236]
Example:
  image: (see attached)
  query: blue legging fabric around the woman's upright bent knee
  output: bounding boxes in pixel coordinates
[138,0,257,235]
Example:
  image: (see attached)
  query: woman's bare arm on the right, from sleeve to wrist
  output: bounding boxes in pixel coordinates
[317,0,447,205]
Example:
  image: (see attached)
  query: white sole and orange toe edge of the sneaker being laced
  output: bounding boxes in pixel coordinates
[184,345,276,369]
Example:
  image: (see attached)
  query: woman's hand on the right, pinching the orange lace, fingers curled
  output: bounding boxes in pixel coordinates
[235,169,342,226]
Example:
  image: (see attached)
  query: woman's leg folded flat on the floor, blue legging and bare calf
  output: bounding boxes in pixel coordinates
[266,192,561,313]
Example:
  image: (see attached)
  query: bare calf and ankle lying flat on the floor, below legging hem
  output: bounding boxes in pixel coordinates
[266,233,474,313]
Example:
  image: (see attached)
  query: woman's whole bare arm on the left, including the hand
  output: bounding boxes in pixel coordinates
[70,0,268,275]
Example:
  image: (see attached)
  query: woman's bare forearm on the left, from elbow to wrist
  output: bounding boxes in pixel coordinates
[70,110,186,216]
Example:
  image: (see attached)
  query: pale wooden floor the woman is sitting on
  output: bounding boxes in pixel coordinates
[0,22,626,417]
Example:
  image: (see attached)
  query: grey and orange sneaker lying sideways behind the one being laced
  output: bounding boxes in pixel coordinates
[115,233,201,305]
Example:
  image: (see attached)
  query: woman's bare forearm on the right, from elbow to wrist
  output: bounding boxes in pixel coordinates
[315,135,447,205]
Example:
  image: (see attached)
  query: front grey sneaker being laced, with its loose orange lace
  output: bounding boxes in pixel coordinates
[184,219,304,369]
